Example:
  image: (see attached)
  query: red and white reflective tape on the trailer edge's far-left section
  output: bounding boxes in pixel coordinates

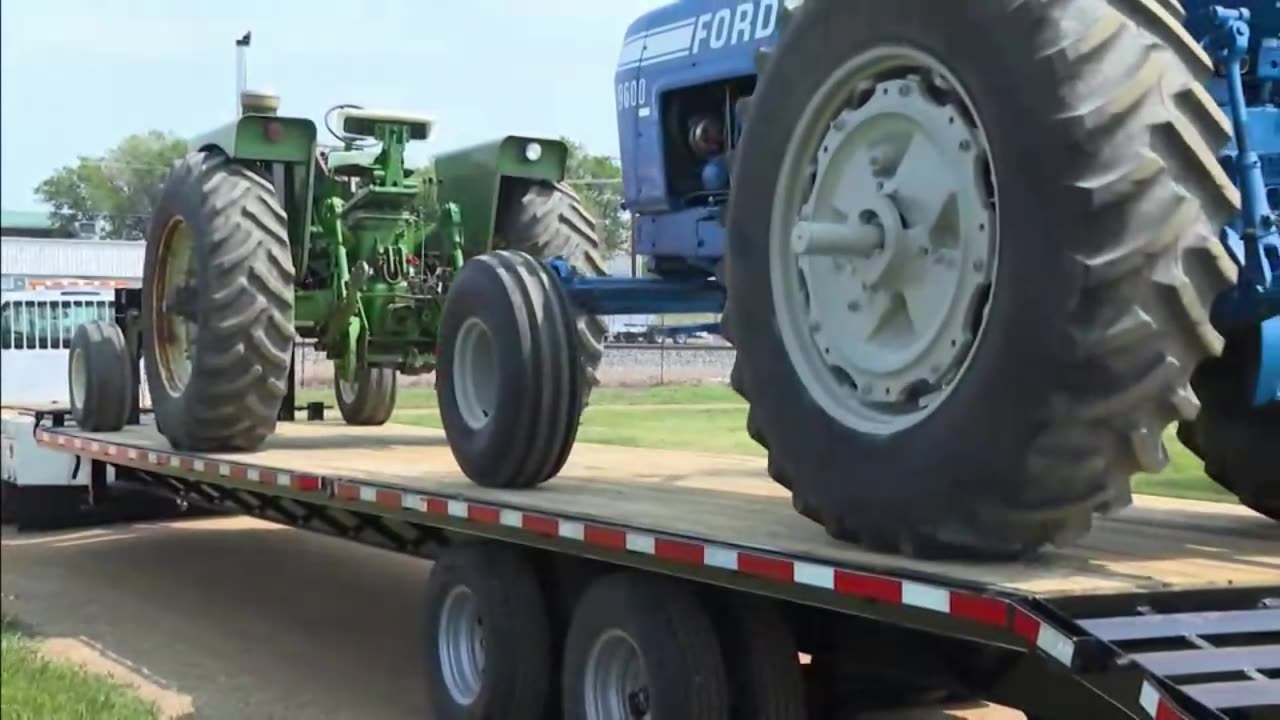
[36,430,324,492]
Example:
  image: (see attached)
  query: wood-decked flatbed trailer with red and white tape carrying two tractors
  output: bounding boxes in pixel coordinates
[22,413,1280,720]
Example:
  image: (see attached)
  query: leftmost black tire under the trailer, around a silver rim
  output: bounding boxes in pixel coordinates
[425,543,554,720]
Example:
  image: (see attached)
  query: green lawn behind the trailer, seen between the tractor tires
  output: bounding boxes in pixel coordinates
[302,383,1235,502]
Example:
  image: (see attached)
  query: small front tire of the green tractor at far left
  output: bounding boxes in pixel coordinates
[67,320,134,433]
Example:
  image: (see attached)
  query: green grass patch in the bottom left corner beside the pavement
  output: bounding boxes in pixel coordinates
[0,618,156,720]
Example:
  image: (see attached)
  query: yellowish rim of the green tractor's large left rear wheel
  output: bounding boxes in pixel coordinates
[151,218,196,396]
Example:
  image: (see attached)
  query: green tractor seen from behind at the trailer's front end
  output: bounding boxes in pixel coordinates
[73,92,605,451]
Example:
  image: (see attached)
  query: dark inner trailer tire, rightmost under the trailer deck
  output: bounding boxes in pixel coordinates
[713,596,809,720]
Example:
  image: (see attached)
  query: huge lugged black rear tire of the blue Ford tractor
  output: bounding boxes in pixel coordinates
[723,0,1239,557]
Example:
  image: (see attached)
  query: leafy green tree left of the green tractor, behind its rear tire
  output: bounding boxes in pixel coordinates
[36,131,187,240]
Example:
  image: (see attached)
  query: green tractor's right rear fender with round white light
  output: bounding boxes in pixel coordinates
[435,135,568,258]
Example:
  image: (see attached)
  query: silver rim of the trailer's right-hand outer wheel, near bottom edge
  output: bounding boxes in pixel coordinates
[582,629,650,720]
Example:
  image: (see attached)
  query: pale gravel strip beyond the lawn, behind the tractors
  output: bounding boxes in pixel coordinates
[289,346,733,387]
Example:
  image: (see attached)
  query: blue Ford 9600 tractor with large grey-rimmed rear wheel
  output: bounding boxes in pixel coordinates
[438,0,1280,557]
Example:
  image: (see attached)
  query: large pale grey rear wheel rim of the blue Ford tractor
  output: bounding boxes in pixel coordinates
[769,46,998,434]
